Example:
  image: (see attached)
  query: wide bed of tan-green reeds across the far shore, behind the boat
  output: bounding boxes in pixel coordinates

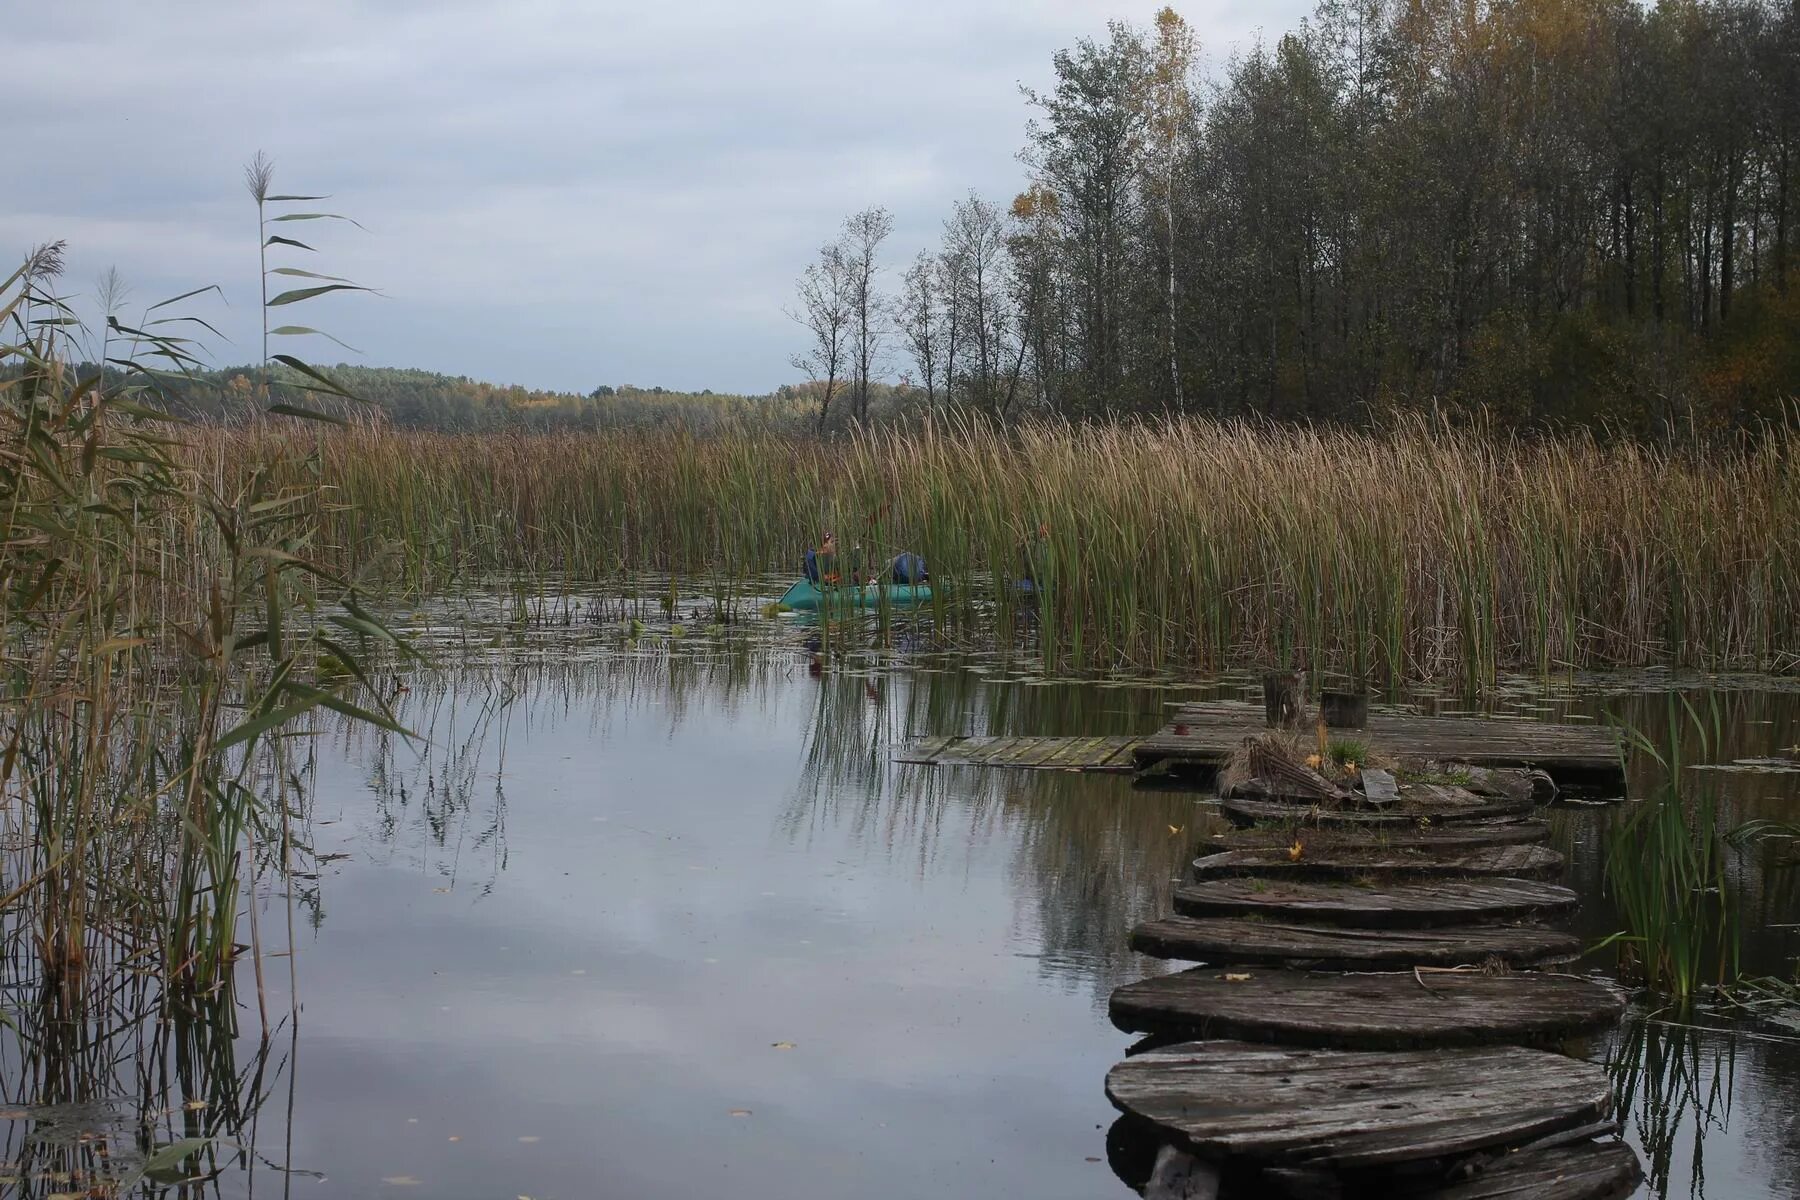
[194,410,1800,684]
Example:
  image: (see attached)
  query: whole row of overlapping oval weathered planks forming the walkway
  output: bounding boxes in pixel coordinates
[1107,766,1642,1200]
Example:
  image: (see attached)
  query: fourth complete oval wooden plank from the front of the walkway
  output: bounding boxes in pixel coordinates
[1175,878,1580,928]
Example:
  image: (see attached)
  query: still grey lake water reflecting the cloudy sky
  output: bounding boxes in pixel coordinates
[0,597,1800,1200]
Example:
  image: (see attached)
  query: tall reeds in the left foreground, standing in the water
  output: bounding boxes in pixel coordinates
[0,232,405,1033]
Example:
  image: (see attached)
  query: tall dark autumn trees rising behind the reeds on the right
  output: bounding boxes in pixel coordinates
[794,0,1800,432]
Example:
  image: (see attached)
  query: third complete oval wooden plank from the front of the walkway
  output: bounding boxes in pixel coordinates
[1130,916,1580,972]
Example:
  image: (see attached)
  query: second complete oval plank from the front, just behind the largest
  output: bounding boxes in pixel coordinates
[1109,966,1625,1049]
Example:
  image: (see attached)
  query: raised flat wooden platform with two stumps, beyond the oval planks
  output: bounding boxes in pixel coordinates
[1136,700,1624,784]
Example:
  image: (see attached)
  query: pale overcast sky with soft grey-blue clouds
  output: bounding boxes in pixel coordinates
[14,0,1310,390]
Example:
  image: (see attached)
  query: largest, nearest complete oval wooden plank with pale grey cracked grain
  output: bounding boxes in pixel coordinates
[1107,1042,1611,1168]
